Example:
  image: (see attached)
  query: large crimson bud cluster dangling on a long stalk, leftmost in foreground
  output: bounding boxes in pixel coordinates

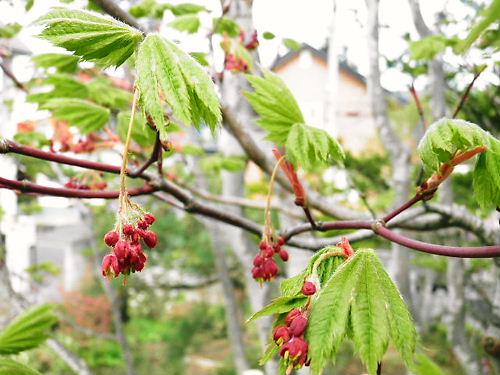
[102,213,158,277]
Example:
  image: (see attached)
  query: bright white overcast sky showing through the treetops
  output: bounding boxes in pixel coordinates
[0,0,492,91]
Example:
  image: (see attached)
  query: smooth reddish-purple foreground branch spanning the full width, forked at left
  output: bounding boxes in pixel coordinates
[0,140,500,258]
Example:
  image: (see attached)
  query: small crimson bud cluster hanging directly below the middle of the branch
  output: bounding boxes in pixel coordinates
[252,237,288,281]
